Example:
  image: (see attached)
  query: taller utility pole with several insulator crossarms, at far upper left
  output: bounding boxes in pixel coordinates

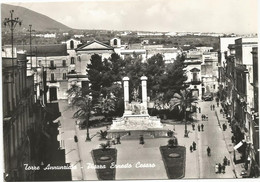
[3,10,22,74]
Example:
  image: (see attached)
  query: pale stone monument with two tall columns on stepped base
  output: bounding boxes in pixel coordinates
[108,76,167,138]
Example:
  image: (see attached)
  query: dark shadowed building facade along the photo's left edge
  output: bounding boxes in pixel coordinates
[2,47,42,181]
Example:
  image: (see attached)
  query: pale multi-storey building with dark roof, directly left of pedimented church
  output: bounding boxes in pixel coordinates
[17,44,69,102]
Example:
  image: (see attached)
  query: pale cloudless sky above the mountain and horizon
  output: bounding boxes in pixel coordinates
[2,0,258,34]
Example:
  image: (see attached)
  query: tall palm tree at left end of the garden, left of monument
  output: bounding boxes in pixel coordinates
[67,85,93,141]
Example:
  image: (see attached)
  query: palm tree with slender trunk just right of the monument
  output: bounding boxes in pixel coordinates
[169,90,196,137]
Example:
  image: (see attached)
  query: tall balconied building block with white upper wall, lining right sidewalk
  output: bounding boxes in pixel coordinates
[220,38,259,176]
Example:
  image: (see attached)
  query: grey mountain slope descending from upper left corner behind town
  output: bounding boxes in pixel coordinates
[1,4,71,31]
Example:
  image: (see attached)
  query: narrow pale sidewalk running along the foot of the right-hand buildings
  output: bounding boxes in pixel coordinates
[215,103,244,178]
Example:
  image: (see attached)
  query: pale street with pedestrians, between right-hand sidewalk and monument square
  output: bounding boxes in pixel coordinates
[196,101,235,178]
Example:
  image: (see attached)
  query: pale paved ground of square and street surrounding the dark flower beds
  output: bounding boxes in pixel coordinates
[59,101,244,180]
